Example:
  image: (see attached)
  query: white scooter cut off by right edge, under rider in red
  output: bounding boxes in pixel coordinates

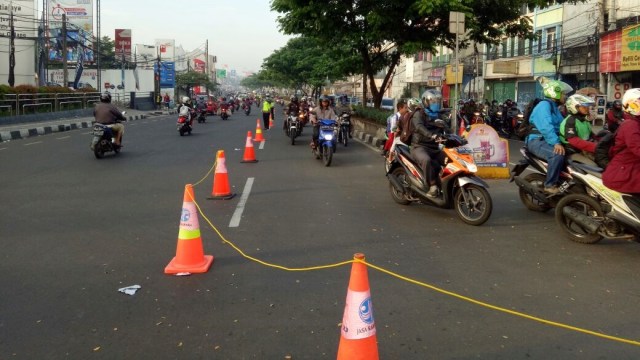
[556,162,640,244]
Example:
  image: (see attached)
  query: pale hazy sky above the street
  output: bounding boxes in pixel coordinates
[39,0,292,75]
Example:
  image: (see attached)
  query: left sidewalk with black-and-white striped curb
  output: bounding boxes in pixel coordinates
[0,109,176,143]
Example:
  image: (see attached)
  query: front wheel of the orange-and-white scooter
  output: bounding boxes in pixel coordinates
[453,184,493,226]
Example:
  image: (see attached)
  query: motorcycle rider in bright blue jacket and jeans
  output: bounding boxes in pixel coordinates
[525,79,573,195]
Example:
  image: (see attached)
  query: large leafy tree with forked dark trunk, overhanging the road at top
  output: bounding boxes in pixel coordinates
[271,0,568,108]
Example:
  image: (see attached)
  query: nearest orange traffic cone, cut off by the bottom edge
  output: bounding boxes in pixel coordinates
[338,253,378,360]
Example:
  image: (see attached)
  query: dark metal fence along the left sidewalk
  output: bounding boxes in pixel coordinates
[0,92,101,116]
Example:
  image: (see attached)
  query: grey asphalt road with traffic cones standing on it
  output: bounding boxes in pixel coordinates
[0,108,640,359]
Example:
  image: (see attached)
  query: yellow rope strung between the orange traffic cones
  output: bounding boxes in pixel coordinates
[180,179,640,346]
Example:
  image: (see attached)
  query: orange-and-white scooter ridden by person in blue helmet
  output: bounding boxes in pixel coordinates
[385,120,493,226]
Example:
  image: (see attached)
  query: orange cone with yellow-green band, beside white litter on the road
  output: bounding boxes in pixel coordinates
[164,184,213,274]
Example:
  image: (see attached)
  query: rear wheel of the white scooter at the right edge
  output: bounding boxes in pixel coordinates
[556,194,604,244]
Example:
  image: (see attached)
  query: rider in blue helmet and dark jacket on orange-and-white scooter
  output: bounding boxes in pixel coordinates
[407,98,444,197]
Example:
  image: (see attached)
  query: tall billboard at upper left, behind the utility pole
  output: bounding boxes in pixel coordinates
[47,0,95,63]
